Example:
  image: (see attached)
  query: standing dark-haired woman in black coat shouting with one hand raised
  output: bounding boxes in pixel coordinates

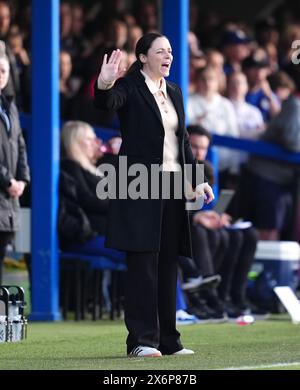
[95,33,213,357]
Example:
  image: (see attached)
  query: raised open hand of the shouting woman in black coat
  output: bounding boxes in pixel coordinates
[99,49,126,84]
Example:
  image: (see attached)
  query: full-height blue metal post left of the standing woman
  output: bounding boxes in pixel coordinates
[31,0,61,321]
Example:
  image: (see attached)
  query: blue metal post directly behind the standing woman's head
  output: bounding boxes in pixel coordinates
[162,0,189,107]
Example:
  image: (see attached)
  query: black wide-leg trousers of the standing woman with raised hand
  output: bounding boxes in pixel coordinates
[125,194,184,354]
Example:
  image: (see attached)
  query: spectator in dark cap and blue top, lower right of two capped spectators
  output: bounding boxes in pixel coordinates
[243,49,280,122]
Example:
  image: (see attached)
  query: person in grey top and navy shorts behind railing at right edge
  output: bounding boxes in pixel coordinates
[244,74,300,240]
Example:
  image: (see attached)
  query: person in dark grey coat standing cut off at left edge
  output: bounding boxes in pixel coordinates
[0,41,30,284]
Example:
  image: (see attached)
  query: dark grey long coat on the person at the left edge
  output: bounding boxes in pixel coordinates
[0,96,30,232]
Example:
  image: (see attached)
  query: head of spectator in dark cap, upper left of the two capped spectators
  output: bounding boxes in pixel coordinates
[221,29,251,75]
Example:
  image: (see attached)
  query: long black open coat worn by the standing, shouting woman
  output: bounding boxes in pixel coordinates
[95,71,202,256]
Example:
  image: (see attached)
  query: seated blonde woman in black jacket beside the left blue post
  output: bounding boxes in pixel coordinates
[59,121,125,261]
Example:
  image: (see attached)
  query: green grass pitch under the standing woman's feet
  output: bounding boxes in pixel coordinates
[0,315,300,370]
